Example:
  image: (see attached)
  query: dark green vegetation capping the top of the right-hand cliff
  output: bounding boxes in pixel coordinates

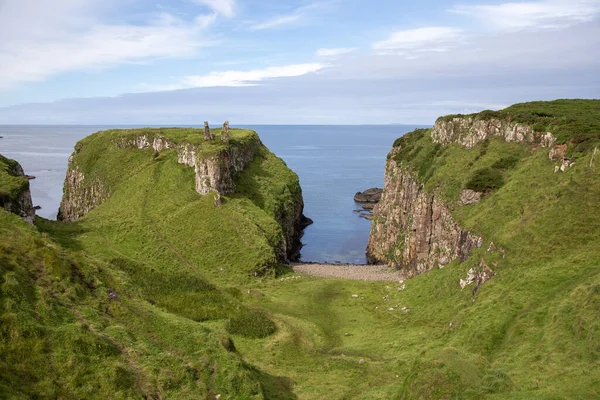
[440,99,600,152]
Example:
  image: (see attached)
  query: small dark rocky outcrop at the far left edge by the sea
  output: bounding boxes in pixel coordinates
[0,155,35,224]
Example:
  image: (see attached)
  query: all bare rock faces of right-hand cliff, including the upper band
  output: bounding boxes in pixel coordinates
[367,116,570,275]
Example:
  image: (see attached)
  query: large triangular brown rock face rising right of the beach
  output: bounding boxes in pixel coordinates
[367,148,483,276]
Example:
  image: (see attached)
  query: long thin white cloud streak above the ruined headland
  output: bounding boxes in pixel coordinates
[141,63,325,91]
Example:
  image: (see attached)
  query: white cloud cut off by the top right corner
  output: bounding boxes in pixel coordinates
[450,0,600,31]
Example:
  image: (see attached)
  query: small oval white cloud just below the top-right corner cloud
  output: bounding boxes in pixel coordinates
[373,26,462,53]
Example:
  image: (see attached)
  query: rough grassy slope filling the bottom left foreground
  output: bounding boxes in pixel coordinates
[0,206,263,399]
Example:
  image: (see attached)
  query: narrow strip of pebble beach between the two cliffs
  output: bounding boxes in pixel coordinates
[292,264,405,282]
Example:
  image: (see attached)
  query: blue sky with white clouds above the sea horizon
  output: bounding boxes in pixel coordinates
[0,0,600,125]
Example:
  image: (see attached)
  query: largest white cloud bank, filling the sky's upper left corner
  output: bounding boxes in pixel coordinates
[0,0,214,88]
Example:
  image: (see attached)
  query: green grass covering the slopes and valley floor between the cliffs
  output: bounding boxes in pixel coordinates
[0,101,600,400]
